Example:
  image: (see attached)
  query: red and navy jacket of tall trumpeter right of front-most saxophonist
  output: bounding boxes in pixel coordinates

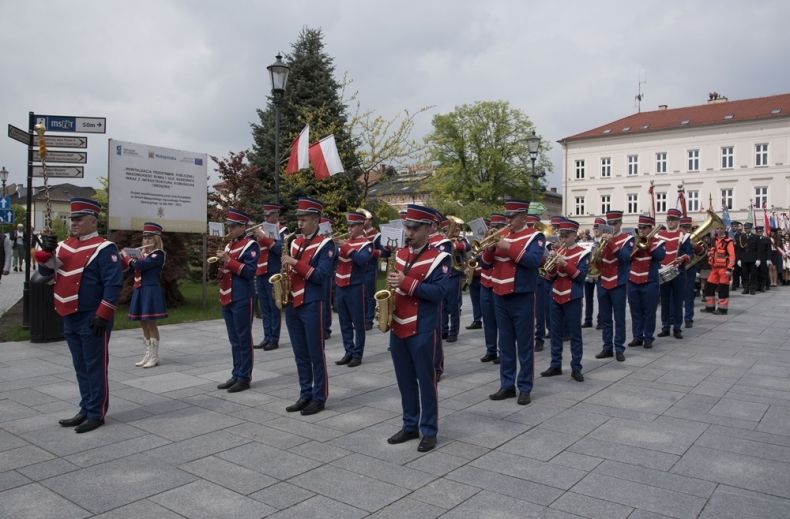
[481,227,546,296]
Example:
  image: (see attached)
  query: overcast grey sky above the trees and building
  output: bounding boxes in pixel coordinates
[0,0,790,193]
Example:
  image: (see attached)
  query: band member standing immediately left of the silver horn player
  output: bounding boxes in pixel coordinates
[628,215,666,348]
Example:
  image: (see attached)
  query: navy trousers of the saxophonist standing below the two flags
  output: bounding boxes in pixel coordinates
[285,301,329,402]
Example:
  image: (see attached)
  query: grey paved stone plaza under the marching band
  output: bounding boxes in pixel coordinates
[0,288,790,519]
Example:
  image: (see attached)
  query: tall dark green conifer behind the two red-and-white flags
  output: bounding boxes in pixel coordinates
[251,28,360,215]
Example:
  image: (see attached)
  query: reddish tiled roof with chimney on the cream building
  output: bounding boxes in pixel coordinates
[559,92,790,144]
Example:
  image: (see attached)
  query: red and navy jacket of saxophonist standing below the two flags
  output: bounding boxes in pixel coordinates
[288,233,336,308]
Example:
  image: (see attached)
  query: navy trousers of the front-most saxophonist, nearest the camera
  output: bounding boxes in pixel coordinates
[390,330,439,436]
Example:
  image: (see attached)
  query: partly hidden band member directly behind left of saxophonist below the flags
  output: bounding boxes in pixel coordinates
[253,204,288,351]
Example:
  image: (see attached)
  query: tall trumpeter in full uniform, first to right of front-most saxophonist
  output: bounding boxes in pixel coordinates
[482,200,545,405]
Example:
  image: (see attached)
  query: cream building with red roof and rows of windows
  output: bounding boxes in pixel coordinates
[559,93,790,230]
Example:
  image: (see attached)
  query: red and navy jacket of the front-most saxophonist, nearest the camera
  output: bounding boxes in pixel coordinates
[392,245,451,339]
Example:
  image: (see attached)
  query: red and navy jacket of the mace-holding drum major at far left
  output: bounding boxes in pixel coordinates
[36,233,123,321]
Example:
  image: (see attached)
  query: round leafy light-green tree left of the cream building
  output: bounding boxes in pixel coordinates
[426,101,552,206]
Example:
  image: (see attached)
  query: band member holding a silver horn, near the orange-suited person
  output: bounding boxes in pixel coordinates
[658,208,694,339]
